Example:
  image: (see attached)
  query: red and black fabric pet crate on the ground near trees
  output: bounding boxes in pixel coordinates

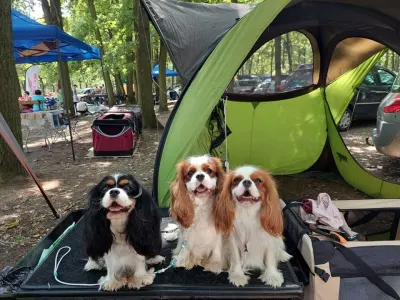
[92,113,139,156]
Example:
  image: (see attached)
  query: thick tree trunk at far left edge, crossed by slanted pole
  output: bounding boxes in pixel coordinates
[0,0,25,177]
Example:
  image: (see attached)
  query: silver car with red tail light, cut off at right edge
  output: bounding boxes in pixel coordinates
[372,75,400,157]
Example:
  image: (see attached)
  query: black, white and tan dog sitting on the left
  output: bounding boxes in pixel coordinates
[84,174,164,291]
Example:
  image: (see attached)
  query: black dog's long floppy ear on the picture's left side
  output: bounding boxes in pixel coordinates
[84,181,113,259]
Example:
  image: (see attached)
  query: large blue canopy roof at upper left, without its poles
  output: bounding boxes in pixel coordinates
[11,9,101,64]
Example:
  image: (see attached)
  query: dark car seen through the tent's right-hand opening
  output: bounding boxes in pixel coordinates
[338,66,396,131]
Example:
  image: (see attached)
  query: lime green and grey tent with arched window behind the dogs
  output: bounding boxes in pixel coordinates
[142,0,400,207]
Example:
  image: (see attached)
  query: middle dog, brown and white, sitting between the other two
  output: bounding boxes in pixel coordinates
[170,155,231,274]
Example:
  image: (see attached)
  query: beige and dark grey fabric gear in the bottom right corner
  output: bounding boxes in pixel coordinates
[281,201,400,300]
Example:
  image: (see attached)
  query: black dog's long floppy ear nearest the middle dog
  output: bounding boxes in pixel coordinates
[126,183,162,256]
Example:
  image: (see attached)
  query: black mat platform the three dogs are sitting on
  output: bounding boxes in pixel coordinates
[15,212,303,299]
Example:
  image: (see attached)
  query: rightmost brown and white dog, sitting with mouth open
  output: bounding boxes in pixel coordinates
[215,166,291,287]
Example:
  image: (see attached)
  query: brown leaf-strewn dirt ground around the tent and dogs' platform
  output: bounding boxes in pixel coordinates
[0,108,399,270]
